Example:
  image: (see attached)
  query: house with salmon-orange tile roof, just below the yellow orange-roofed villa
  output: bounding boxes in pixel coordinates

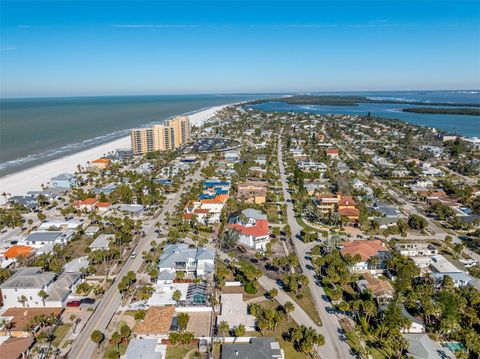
[340,240,391,274]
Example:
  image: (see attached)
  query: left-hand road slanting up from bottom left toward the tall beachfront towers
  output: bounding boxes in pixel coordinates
[68,166,207,359]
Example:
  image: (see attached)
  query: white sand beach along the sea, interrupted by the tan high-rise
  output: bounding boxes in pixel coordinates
[0,105,229,204]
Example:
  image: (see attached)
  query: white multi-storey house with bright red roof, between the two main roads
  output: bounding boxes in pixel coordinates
[230,208,270,250]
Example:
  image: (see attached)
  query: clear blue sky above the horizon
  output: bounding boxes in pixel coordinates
[0,0,480,97]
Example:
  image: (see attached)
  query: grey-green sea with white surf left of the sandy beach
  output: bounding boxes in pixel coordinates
[0,95,262,176]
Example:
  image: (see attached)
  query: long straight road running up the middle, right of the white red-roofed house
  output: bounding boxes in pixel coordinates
[278,136,353,359]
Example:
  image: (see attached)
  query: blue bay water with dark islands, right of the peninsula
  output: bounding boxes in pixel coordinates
[248,91,480,137]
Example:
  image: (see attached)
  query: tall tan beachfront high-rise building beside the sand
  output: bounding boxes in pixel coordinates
[130,116,190,155]
